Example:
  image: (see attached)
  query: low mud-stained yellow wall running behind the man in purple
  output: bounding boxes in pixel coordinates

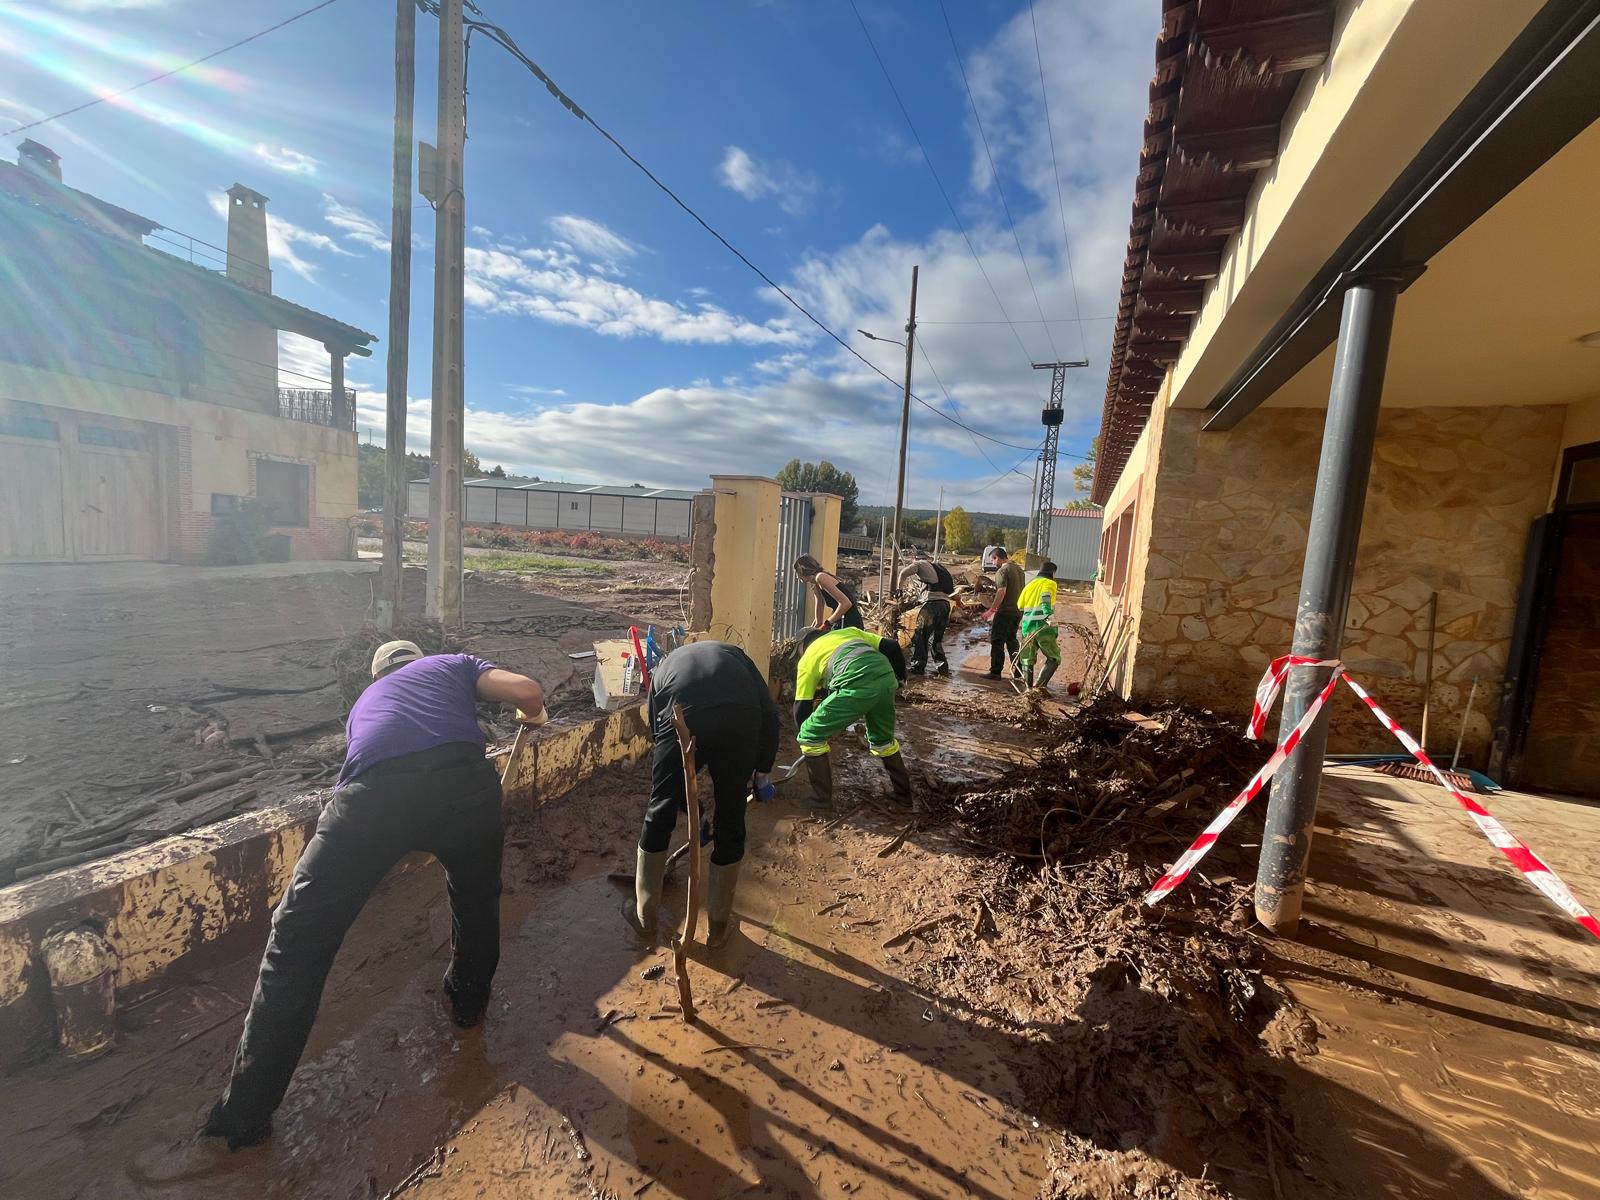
[0,704,650,1069]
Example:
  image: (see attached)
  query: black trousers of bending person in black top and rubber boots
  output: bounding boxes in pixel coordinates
[638,704,762,867]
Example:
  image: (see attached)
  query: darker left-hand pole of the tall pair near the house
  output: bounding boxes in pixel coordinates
[379,0,416,640]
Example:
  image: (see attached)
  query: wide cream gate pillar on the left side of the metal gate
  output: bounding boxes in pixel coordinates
[709,475,782,678]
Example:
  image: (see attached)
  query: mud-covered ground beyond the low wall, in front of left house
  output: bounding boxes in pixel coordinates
[0,560,685,885]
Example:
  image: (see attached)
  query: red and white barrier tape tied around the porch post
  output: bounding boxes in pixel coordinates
[1144,654,1600,938]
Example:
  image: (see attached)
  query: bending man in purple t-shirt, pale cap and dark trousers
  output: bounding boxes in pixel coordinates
[200,642,544,1150]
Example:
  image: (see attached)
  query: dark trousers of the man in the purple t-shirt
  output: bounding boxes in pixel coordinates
[206,744,506,1138]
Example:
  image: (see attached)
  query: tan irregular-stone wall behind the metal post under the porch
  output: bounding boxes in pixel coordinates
[1128,406,1565,763]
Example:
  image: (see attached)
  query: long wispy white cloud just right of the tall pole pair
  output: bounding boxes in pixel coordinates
[466,233,806,346]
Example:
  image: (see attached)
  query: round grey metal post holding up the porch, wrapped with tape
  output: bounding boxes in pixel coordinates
[1256,275,1400,936]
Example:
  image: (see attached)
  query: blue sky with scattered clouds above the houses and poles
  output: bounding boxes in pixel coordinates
[0,0,1158,512]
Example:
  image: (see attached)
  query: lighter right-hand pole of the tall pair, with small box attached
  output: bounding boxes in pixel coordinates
[427,0,467,629]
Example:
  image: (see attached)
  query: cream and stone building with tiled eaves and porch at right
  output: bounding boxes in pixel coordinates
[1093,0,1600,809]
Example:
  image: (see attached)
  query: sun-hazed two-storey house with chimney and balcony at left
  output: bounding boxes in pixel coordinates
[0,141,374,563]
